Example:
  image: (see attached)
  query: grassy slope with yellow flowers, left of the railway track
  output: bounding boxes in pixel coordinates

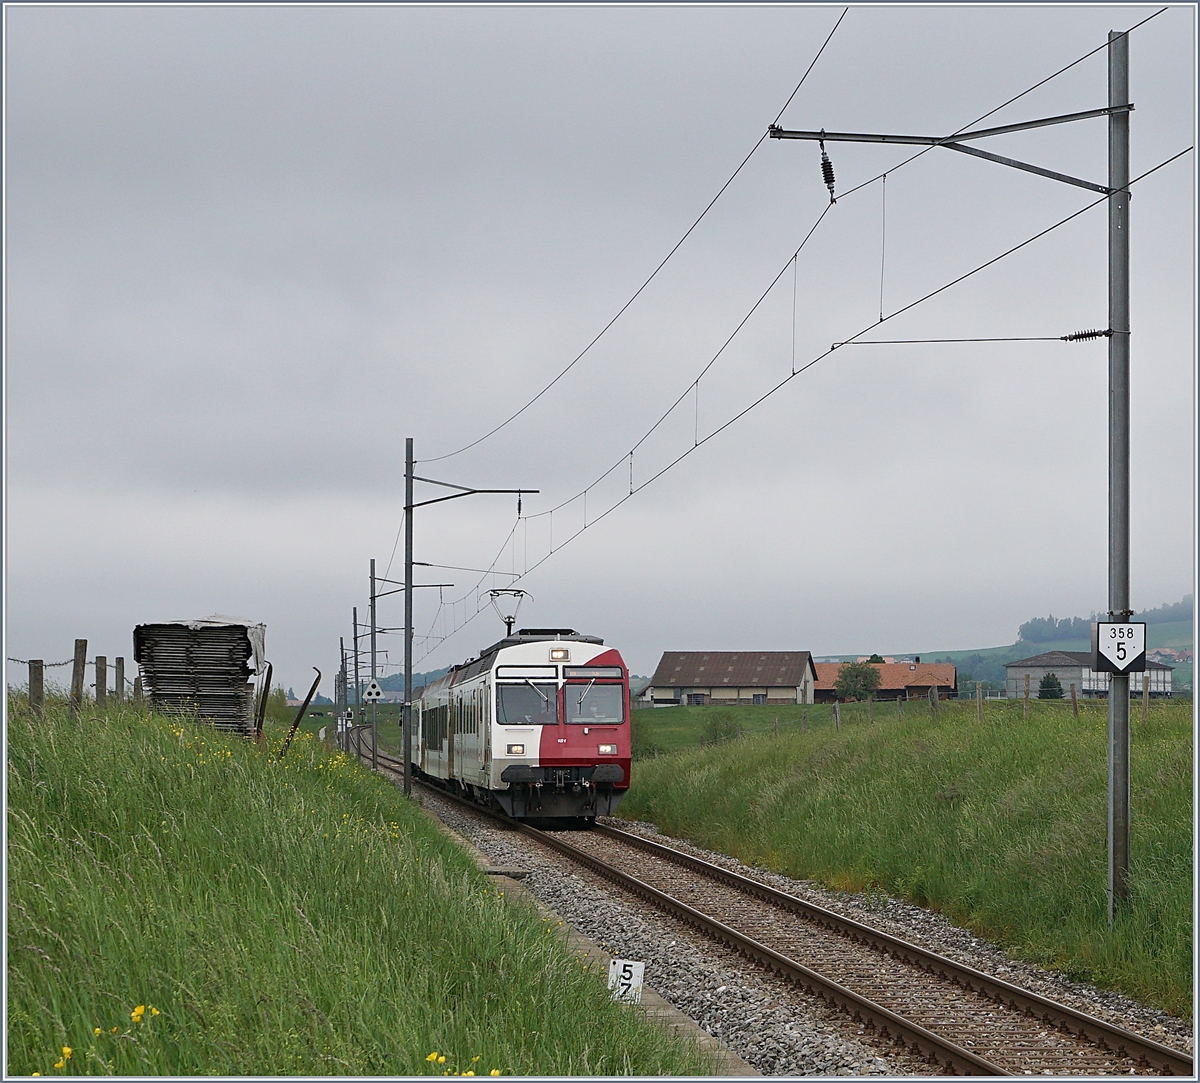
[7,696,707,1076]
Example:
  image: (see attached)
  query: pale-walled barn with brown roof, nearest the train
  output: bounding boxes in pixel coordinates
[642,651,817,707]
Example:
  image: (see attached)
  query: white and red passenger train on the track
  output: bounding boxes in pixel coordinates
[413,628,630,820]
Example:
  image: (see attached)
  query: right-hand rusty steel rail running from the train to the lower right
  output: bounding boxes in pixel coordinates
[594,824,1193,1076]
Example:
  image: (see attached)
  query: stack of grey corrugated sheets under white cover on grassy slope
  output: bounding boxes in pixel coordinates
[133,616,266,737]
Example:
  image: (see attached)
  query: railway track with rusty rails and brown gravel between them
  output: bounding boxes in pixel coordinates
[357,750,1193,1076]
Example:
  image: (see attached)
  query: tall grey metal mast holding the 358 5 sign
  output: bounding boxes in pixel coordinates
[1109,30,1133,923]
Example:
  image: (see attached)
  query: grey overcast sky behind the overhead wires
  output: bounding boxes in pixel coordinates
[5,5,1196,694]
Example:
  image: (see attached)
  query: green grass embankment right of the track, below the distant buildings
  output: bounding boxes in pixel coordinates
[620,701,1193,1018]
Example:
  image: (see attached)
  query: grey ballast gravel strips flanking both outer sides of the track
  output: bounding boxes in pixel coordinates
[420,791,1193,1076]
